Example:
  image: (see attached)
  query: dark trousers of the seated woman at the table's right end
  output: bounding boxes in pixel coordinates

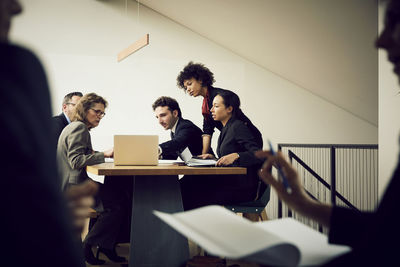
[179,175,258,213]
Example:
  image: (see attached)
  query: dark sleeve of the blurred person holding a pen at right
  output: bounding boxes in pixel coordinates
[326,152,400,266]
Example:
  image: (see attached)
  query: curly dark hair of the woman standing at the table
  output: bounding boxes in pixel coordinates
[176,61,215,92]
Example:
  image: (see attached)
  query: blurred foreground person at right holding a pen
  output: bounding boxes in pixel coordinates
[256,0,400,266]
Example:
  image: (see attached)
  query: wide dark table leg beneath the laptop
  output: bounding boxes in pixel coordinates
[129,175,189,267]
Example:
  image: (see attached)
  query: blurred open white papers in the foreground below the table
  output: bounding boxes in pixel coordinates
[154,206,350,266]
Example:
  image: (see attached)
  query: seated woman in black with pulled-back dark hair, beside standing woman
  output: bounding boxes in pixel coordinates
[180,91,262,210]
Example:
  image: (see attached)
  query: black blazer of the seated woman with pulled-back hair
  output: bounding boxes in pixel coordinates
[217,118,263,183]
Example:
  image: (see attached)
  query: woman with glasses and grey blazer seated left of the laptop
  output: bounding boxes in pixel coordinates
[57,93,130,265]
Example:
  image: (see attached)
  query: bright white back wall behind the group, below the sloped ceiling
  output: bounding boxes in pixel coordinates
[12,0,378,153]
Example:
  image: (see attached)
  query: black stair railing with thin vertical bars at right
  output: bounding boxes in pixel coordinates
[280,144,378,228]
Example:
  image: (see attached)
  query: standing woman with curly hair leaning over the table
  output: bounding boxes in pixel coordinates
[177,61,263,154]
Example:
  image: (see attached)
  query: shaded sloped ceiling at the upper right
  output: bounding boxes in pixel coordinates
[140,0,378,126]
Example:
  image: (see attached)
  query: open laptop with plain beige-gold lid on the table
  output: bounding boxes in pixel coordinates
[114,135,158,166]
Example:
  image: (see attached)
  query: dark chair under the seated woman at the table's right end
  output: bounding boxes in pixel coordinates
[225,183,271,222]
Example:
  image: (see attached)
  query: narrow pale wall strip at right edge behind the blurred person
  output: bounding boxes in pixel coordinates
[379,5,400,198]
